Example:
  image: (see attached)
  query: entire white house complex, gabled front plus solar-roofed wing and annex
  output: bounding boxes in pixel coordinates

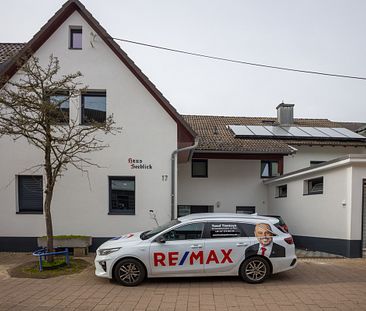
[0,0,366,257]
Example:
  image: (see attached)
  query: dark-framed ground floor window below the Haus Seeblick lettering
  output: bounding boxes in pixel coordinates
[109,176,135,215]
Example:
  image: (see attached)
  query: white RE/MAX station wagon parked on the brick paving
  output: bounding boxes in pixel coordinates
[95,213,296,286]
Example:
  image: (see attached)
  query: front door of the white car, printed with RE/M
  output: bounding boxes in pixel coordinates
[150,222,204,275]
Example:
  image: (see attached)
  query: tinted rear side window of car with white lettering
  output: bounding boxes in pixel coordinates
[205,222,245,239]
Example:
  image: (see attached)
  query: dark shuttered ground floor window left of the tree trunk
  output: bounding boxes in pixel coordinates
[18,175,43,214]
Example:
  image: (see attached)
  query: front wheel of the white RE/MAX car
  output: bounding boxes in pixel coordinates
[113,258,146,286]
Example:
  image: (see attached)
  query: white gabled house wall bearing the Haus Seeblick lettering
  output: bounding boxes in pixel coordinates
[0,12,177,237]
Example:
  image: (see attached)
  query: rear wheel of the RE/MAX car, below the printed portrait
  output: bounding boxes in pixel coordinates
[239,256,270,284]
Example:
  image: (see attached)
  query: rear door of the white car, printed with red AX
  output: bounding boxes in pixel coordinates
[204,221,254,274]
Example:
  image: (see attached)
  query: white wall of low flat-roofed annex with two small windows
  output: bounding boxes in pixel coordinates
[266,155,366,257]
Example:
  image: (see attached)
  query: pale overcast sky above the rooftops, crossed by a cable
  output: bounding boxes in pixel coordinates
[0,0,366,122]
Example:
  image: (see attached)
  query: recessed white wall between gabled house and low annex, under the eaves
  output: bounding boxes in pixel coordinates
[178,159,267,213]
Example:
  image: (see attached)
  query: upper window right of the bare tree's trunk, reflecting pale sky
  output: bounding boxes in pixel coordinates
[81,92,107,124]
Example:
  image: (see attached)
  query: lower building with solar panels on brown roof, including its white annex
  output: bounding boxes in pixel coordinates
[178,104,366,257]
